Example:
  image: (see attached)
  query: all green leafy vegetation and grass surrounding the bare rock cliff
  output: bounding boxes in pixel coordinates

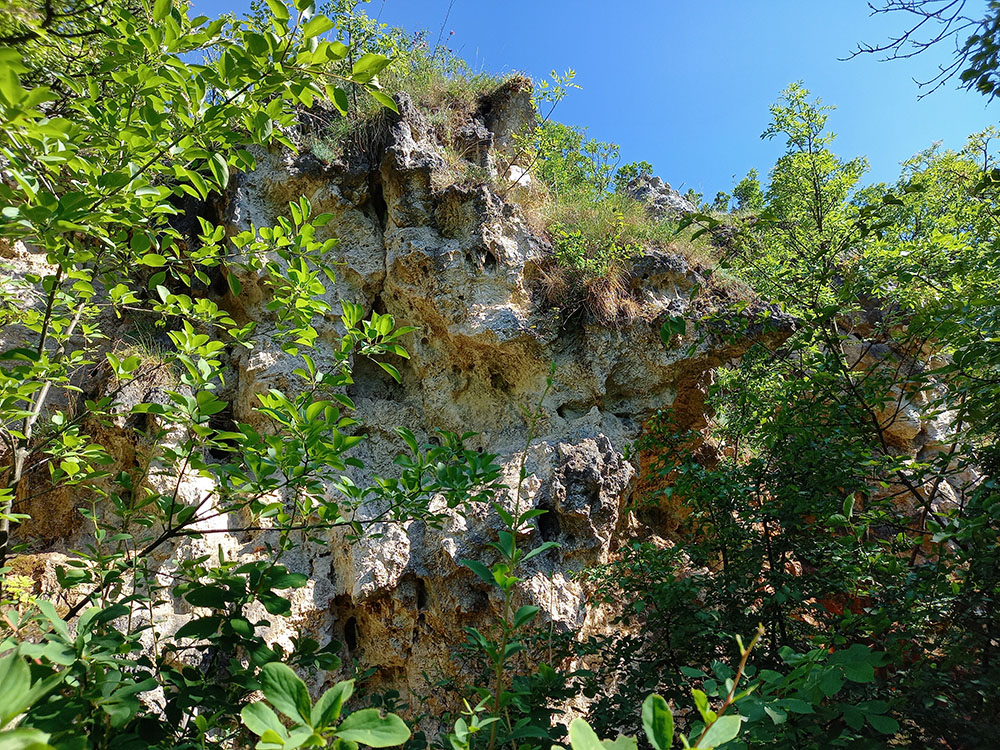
[0,0,1000,750]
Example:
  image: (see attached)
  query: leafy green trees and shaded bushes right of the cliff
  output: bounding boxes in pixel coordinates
[593,85,1000,747]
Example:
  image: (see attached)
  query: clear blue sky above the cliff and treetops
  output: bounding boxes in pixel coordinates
[194,0,1000,198]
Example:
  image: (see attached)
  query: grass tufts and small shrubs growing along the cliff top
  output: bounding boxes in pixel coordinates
[308,14,746,322]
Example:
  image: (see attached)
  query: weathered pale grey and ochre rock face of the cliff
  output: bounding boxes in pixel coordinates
[1,86,780,712]
